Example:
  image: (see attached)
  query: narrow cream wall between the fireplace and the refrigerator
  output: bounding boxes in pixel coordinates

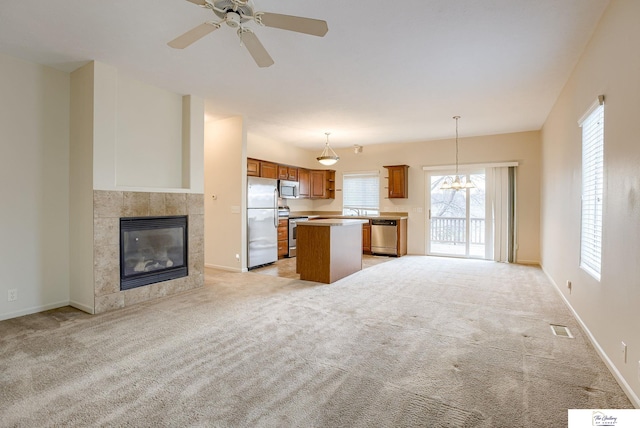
[204,117,247,271]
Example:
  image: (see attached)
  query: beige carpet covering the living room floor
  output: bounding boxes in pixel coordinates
[0,256,632,427]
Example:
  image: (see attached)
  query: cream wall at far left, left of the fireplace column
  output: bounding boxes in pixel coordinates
[0,54,70,320]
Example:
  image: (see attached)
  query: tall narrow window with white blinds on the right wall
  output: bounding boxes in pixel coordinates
[579,96,604,280]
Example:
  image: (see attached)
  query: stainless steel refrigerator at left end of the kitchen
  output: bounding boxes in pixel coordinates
[247,177,279,269]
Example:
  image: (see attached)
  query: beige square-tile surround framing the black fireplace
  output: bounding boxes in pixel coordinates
[93,190,204,314]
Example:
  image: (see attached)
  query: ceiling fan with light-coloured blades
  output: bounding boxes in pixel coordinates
[168,0,329,67]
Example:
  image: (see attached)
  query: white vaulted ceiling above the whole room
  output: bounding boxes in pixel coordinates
[0,0,608,150]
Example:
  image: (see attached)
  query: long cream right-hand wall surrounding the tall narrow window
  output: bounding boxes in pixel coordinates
[541,0,640,406]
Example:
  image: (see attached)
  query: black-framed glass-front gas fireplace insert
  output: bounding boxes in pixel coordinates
[120,216,189,290]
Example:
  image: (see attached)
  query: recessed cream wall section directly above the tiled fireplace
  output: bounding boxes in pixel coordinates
[93,61,204,193]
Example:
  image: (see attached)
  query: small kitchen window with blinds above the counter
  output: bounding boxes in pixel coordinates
[342,171,380,215]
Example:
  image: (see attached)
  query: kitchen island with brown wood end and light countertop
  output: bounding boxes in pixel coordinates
[296,218,368,284]
